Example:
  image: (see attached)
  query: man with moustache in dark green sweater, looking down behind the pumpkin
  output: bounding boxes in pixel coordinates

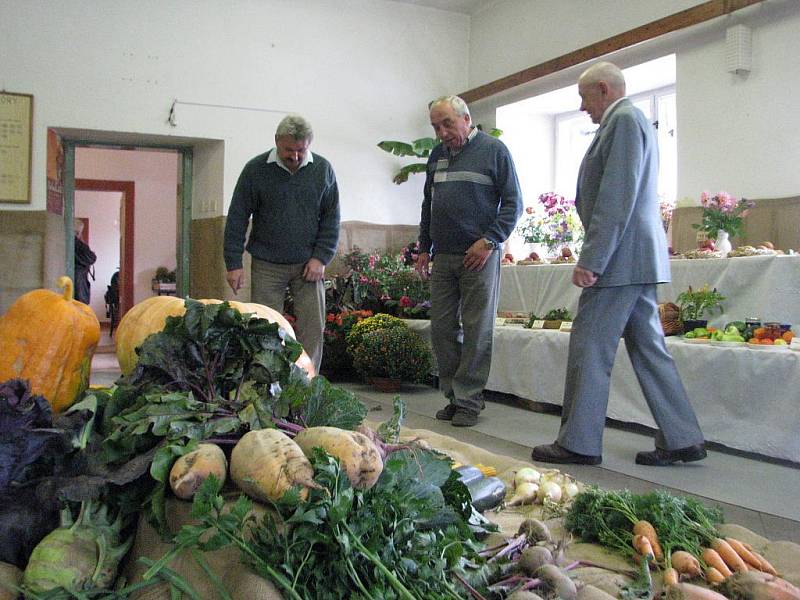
[224,115,339,372]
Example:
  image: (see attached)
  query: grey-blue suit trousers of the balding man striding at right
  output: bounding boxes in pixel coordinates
[558,284,703,456]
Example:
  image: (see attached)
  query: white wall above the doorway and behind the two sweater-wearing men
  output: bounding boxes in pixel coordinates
[0,0,469,223]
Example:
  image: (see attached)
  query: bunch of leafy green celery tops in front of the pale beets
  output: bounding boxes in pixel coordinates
[158,449,488,600]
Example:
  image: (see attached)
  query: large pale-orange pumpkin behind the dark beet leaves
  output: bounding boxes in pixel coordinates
[116,296,316,377]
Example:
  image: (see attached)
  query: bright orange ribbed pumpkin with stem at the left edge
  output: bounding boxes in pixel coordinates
[0,277,100,412]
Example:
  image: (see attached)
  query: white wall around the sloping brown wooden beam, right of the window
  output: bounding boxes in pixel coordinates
[469,0,800,202]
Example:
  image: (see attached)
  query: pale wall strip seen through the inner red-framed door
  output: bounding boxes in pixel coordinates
[75,190,122,321]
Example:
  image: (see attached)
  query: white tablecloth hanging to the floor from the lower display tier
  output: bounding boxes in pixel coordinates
[407,321,800,463]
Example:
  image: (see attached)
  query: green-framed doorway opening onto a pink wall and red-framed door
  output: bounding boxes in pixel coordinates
[63,139,192,322]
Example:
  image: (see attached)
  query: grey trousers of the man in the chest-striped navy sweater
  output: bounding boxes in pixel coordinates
[430,250,500,412]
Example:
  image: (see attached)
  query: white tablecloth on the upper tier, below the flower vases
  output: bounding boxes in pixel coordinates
[498,256,800,328]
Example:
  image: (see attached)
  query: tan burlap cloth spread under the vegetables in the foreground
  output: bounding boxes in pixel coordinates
[123,429,800,600]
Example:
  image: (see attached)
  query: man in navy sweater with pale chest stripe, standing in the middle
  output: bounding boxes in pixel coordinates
[417,96,522,427]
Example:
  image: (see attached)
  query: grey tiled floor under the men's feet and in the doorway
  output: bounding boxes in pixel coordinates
[92,332,800,543]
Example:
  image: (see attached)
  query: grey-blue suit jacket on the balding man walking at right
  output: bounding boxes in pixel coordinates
[575,98,670,287]
